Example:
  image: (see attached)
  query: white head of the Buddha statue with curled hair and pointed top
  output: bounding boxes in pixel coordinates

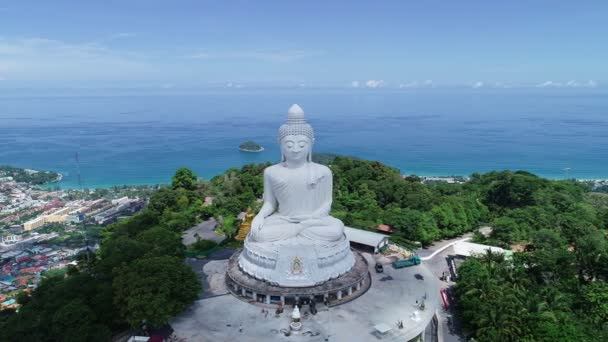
[279,104,315,162]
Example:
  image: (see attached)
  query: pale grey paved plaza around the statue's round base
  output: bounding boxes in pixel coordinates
[170,253,440,342]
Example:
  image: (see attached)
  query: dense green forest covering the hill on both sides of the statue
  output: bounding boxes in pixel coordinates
[0,155,608,341]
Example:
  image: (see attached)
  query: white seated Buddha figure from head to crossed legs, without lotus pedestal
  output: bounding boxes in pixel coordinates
[250,104,344,244]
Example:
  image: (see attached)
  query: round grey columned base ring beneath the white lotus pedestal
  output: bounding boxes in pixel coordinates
[226,251,371,306]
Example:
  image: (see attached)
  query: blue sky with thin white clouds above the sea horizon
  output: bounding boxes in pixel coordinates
[0,0,608,88]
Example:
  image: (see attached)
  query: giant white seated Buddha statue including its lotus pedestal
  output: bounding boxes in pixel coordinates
[239,104,354,286]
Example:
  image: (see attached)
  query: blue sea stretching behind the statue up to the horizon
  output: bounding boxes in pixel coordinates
[0,89,608,188]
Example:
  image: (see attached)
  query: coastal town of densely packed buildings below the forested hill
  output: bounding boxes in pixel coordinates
[0,170,151,310]
